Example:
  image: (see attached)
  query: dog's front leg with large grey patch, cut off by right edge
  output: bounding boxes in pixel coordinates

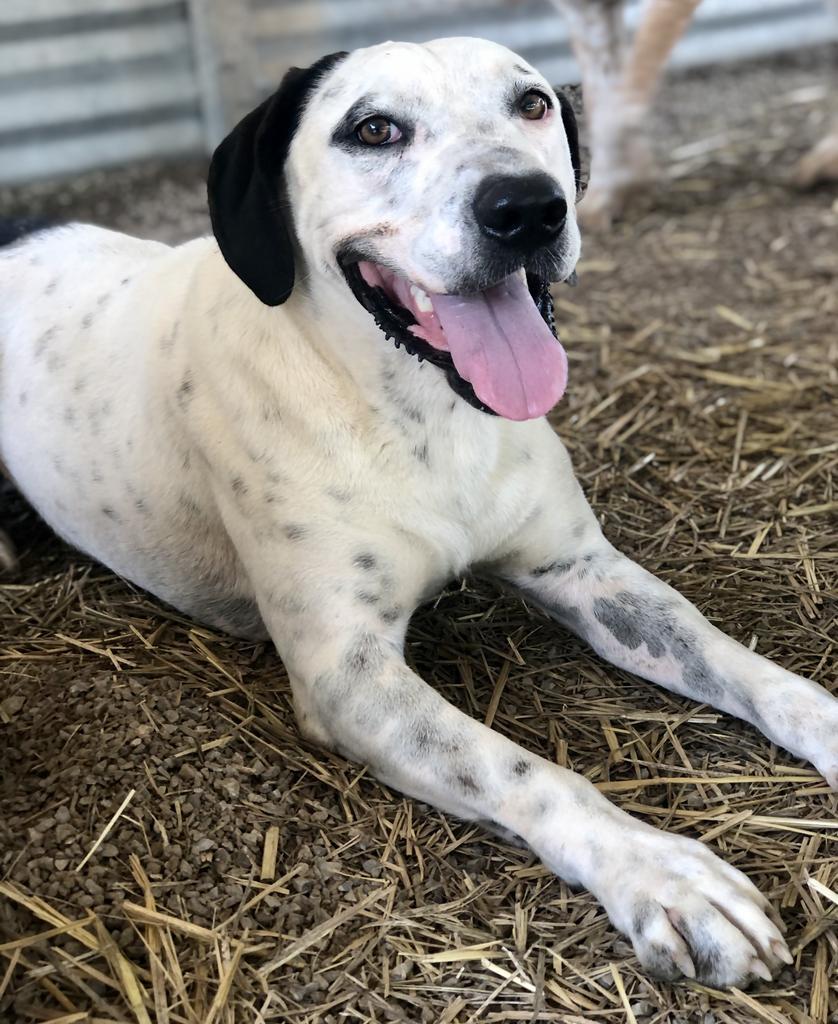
[501,512,838,788]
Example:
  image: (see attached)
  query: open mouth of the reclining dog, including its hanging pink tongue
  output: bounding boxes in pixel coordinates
[341,260,568,420]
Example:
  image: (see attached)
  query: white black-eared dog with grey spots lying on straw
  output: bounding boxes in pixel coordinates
[0,39,838,987]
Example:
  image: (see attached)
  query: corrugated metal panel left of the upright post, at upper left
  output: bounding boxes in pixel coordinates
[0,0,206,182]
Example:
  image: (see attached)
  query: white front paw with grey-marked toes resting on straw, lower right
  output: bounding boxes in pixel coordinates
[599,834,792,988]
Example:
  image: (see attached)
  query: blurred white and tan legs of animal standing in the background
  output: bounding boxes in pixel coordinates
[553,0,838,228]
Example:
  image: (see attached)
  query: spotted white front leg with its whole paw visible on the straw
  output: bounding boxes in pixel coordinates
[267,586,790,986]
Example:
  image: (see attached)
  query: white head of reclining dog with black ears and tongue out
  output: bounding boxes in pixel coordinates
[209,39,580,420]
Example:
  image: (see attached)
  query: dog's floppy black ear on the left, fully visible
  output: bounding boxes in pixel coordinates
[207,52,346,306]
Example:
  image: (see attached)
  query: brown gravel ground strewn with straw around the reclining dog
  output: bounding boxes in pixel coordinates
[0,50,838,1024]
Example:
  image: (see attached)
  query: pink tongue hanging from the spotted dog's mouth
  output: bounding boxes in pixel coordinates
[430,274,568,420]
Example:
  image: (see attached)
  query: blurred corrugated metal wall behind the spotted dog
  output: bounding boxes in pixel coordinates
[0,0,838,181]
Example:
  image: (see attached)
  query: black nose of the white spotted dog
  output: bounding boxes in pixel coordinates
[473,172,568,252]
